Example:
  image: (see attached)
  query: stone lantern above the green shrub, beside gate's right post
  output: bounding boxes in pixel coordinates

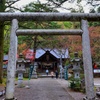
[72,52,81,79]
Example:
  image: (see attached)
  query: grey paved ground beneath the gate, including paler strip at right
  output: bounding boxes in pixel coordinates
[0,78,100,100]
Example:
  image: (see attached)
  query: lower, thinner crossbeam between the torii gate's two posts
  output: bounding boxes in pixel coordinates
[16,29,82,36]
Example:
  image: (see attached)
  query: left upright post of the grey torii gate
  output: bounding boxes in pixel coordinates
[5,19,18,100]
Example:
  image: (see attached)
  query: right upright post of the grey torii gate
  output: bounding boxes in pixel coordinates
[81,20,95,100]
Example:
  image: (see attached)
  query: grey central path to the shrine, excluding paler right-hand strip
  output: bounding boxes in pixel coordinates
[0,78,74,100]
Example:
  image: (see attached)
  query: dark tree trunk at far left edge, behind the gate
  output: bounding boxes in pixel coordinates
[0,0,23,83]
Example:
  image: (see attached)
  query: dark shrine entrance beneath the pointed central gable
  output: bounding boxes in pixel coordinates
[36,51,59,73]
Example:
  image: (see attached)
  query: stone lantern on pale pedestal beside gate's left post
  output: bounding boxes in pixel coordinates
[17,54,26,87]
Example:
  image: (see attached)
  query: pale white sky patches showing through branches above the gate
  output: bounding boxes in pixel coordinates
[14,0,97,13]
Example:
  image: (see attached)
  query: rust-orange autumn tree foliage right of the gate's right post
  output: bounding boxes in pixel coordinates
[89,26,100,62]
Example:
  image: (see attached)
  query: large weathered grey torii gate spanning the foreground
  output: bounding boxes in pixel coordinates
[0,12,100,100]
